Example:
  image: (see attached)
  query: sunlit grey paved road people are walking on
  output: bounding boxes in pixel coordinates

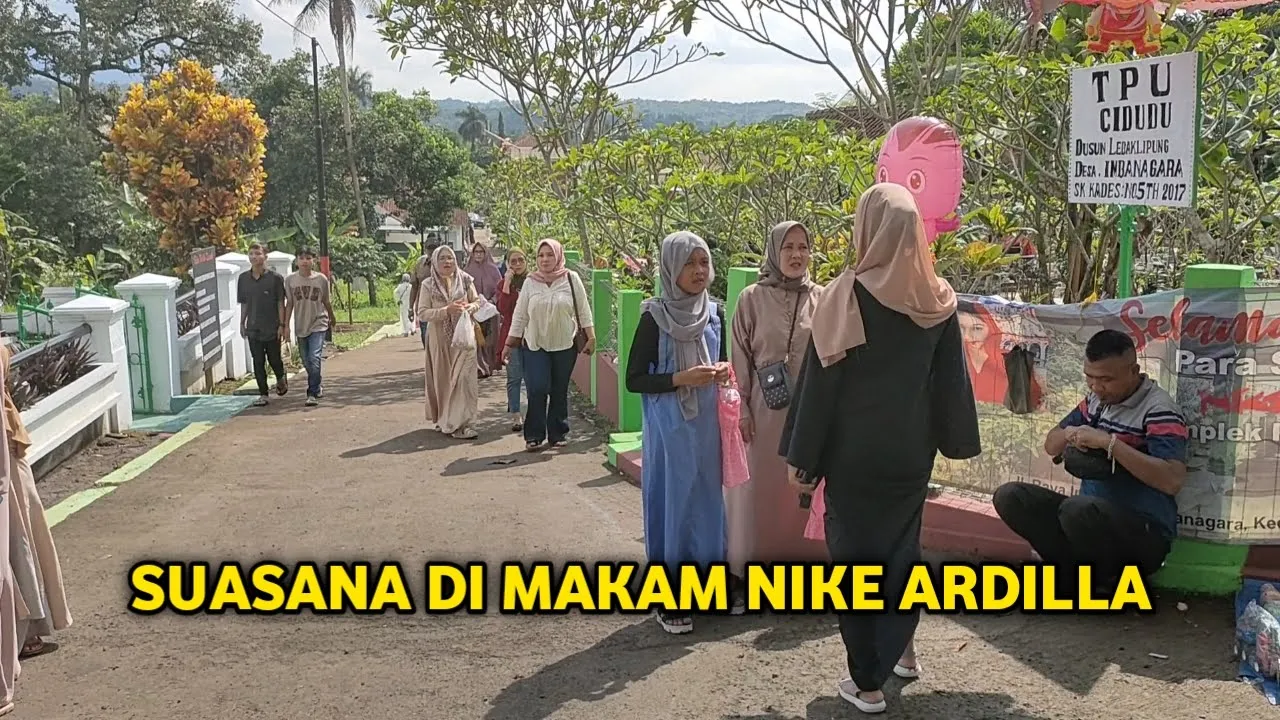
[14,338,1270,720]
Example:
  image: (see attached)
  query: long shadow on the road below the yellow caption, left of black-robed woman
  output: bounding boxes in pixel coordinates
[485,615,837,720]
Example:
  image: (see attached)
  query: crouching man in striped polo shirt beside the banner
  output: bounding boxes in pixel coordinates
[992,331,1188,588]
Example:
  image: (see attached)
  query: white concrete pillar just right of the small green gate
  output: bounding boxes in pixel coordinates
[115,273,182,414]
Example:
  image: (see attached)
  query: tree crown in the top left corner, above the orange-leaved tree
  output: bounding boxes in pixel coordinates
[15,0,262,129]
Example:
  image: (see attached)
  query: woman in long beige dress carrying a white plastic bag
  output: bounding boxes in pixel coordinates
[417,245,480,439]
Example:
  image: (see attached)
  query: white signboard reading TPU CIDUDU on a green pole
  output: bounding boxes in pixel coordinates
[1068,53,1199,208]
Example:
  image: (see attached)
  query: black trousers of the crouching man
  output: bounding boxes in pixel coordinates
[992,483,1170,583]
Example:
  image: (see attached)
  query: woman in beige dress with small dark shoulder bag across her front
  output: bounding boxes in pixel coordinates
[724,222,827,577]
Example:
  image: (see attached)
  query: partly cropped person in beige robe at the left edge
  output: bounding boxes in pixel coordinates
[0,340,72,659]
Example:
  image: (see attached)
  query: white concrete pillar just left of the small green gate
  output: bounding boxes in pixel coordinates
[51,295,133,432]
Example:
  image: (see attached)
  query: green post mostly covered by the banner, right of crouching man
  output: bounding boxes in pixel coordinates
[1155,264,1257,594]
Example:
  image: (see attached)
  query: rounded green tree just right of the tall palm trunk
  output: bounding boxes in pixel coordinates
[360,92,479,229]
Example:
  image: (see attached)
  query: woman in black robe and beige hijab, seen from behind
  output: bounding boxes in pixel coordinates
[780,183,980,712]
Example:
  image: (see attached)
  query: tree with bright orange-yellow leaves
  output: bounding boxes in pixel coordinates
[102,60,266,260]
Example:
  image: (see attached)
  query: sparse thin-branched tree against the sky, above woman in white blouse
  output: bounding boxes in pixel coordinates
[378,0,709,261]
